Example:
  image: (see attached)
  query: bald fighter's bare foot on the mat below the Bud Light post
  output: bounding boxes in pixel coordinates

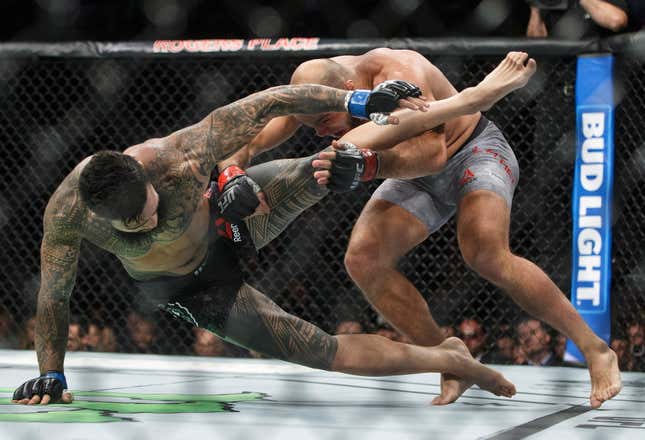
[587,346,623,409]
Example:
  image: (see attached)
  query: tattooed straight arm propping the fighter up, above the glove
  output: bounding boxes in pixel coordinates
[35,178,86,374]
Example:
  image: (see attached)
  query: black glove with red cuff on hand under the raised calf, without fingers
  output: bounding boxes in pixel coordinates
[327,142,380,193]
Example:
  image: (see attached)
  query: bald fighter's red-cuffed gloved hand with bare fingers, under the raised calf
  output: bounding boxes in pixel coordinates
[311,141,380,192]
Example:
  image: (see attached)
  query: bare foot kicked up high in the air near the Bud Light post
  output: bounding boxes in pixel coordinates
[473,52,537,111]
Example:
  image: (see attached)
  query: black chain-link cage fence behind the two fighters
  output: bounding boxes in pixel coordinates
[0,40,645,372]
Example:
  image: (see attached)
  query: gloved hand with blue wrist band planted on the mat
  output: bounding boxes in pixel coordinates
[11,371,74,405]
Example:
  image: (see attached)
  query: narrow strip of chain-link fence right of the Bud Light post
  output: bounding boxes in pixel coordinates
[612,55,645,371]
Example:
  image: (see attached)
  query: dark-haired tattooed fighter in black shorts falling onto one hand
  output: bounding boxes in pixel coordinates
[13,65,515,404]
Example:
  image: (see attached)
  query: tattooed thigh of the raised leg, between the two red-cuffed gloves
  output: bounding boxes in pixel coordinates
[246,150,329,249]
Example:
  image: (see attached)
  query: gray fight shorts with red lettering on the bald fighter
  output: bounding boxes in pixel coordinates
[372,116,520,233]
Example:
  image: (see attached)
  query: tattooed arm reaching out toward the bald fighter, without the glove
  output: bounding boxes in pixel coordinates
[170,84,350,175]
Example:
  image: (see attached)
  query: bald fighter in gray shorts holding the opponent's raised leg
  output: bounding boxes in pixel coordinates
[220,49,621,408]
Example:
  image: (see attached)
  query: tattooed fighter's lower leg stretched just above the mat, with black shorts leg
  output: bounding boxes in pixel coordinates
[166,284,515,396]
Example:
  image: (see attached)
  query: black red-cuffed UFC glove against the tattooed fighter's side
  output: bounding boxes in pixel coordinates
[217,165,261,223]
